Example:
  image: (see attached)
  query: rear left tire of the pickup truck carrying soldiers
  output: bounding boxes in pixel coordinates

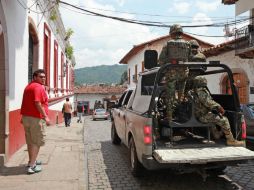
[129,138,143,177]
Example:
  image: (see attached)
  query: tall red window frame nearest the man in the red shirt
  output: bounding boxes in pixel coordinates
[43,23,51,87]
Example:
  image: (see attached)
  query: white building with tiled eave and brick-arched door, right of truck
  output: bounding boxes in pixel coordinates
[203,40,254,104]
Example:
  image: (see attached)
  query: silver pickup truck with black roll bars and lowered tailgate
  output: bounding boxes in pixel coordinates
[111,49,254,179]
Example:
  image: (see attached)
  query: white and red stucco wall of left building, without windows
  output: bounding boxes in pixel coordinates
[0,0,74,160]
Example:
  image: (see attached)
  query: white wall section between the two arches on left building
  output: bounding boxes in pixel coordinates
[2,1,28,111]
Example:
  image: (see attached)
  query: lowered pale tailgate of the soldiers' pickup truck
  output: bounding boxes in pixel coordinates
[153,147,254,164]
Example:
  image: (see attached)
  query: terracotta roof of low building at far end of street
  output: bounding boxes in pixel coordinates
[74,85,126,94]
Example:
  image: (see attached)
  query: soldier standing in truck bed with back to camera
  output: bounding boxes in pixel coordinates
[159,24,190,121]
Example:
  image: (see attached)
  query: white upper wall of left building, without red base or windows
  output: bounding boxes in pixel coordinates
[1,0,71,111]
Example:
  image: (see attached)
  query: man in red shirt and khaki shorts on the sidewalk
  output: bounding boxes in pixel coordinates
[21,69,49,174]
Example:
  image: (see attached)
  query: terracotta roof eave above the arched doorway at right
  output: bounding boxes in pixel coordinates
[202,40,238,57]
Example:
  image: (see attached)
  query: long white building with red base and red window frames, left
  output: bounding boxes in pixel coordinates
[0,0,74,165]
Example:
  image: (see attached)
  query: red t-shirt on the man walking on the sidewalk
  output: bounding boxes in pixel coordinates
[20,81,48,118]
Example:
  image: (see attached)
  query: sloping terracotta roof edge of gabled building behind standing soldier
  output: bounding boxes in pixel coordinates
[119,33,213,64]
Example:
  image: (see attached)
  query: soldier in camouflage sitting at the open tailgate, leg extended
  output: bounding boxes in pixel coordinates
[194,76,244,146]
